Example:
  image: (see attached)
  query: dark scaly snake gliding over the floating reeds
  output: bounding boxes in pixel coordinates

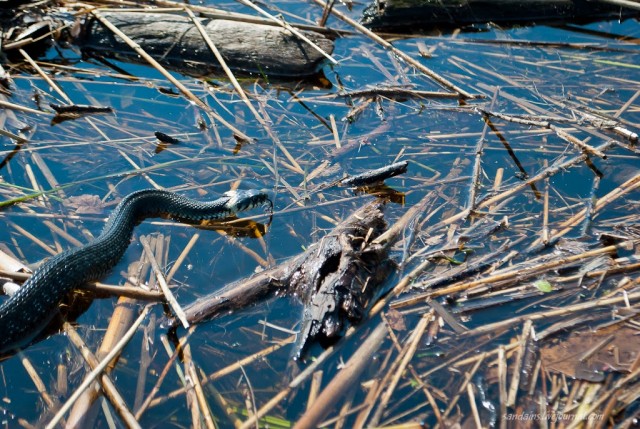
[0,189,271,353]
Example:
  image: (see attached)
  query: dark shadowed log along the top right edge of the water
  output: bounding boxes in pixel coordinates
[363,0,638,30]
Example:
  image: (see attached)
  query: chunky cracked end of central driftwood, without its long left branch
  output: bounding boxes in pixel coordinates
[289,202,394,357]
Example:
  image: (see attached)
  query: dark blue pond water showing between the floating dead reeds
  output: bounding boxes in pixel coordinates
[0,2,640,427]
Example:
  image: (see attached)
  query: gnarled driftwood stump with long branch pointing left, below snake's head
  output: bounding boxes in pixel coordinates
[178,200,394,357]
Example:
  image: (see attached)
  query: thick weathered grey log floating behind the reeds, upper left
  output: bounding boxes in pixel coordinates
[79,12,333,77]
